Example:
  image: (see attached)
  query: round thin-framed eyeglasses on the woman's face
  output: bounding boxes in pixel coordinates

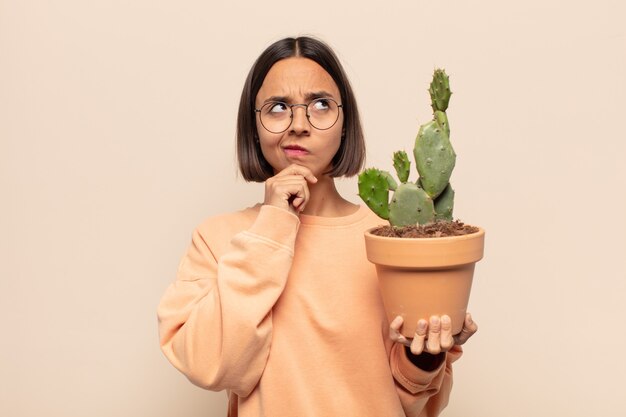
[254,98,343,133]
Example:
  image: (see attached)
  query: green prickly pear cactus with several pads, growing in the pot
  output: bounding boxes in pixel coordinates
[359,69,456,227]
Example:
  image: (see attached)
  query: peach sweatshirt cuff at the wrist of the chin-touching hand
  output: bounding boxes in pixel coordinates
[248,205,300,251]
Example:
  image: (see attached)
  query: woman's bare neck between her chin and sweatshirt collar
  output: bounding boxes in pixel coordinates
[302,175,358,217]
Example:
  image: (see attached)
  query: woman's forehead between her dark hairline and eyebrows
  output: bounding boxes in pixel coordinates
[256,57,340,102]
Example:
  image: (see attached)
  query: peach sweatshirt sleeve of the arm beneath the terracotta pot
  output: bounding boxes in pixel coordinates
[390,343,463,417]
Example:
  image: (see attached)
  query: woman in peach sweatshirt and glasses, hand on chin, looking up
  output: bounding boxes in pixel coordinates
[158,37,476,417]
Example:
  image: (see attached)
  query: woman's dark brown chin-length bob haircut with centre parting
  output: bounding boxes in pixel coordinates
[237,36,365,182]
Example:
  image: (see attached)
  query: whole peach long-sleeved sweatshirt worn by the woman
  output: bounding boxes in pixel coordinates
[158,205,461,417]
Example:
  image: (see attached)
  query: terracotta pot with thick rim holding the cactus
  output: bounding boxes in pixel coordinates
[365,228,485,338]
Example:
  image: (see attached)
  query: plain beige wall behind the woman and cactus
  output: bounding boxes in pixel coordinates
[0,0,626,417]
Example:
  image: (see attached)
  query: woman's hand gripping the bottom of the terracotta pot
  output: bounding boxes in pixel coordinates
[389,313,478,355]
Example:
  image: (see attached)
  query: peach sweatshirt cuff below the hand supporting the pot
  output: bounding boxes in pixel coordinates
[391,343,448,394]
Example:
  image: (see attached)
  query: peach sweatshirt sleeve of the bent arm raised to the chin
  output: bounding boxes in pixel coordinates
[157,206,299,397]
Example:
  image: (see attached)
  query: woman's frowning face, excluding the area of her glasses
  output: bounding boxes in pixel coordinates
[255,57,343,176]
